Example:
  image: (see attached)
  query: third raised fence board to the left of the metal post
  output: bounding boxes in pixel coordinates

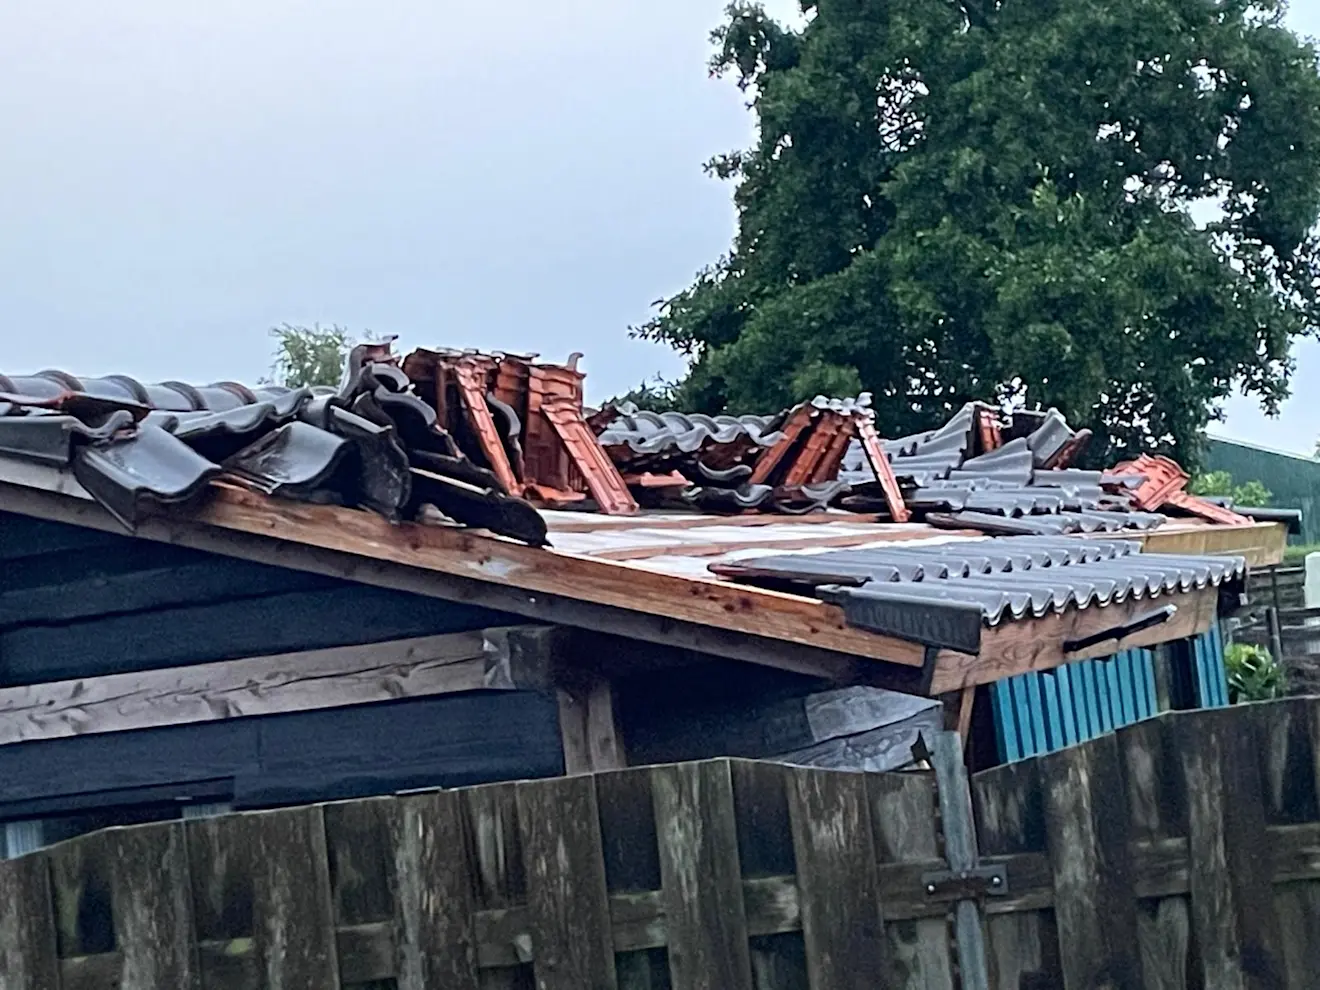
[517,776,616,990]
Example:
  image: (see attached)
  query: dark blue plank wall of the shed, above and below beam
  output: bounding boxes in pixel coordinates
[0,513,562,821]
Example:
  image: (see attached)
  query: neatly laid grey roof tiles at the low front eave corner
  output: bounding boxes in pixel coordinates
[711,536,1246,653]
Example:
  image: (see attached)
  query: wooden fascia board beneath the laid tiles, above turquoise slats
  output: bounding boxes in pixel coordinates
[931,587,1220,694]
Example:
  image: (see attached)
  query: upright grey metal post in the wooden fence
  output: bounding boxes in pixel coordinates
[931,733,990,990]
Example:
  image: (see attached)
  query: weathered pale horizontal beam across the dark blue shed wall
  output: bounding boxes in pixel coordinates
[0,628,549,746]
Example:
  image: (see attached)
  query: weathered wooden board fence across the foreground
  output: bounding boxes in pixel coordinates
[0,700,1320,990]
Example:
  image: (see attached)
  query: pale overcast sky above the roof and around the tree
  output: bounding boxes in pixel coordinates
[0,0,1320,453]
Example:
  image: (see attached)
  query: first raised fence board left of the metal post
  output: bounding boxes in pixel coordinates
[787,768,886,990]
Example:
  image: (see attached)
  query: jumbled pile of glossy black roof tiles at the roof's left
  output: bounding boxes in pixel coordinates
[0,343,546,545]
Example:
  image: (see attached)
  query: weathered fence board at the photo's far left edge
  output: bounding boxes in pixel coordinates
[0,854,59,990]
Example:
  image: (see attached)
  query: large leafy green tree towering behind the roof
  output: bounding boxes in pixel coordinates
[634,0,1320,457]
